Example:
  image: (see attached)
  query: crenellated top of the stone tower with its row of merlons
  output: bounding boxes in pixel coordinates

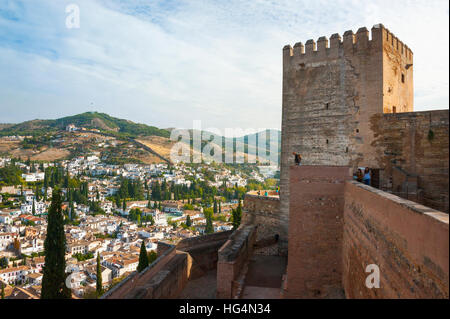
[283,24,413,63]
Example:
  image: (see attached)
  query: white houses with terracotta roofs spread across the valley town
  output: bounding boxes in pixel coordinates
[0,156,253,296]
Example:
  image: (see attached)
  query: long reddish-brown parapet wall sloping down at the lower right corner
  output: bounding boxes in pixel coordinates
[342,181,449,298]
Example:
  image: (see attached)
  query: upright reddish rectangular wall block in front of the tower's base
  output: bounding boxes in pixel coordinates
[284,166,350,298]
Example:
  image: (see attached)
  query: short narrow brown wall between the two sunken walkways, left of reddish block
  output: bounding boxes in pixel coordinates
[217,224,256,299]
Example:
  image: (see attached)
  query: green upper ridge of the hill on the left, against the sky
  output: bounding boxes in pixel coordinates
[0,112,170,137]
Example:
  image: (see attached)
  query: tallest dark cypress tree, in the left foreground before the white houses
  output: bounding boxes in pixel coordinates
[41,190,71,299]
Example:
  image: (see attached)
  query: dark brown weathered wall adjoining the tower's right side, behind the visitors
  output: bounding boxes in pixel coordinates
[371,110,449,213]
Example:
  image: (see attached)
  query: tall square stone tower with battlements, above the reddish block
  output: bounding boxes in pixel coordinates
[280,24,413,252]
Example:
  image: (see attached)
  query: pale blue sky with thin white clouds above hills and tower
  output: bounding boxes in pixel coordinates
[0,0,449,129]
